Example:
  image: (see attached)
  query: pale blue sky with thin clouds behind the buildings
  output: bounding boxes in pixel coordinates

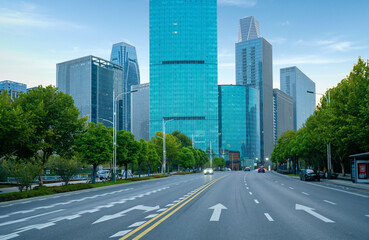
[0,0,369,104]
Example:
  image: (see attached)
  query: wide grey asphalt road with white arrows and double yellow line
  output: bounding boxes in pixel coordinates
[0,171,369,240]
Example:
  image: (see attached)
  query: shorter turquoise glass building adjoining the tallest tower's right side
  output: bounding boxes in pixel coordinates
[219,85,260,165]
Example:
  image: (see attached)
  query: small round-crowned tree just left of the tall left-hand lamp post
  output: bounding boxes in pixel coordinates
[75,122,113,183]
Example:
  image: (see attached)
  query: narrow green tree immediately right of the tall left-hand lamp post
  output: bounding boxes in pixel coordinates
[117,130,140,178]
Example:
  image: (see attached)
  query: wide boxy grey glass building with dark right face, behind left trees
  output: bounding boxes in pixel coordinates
[56,56,123,130]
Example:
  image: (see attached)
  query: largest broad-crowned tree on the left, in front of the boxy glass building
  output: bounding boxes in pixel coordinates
[14,86,87,186]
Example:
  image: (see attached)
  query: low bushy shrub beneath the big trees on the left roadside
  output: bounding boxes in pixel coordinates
[48,156,82,185]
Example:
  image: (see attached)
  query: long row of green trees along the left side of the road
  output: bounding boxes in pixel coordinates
[0,86,224,190]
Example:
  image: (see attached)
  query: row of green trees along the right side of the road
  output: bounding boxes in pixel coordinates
[271,58,369,174]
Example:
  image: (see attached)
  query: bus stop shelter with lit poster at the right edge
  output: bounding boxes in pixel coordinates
[350,152,369,183]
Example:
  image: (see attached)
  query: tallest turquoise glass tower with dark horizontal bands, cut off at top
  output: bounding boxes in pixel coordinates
[150,0,218,154]
